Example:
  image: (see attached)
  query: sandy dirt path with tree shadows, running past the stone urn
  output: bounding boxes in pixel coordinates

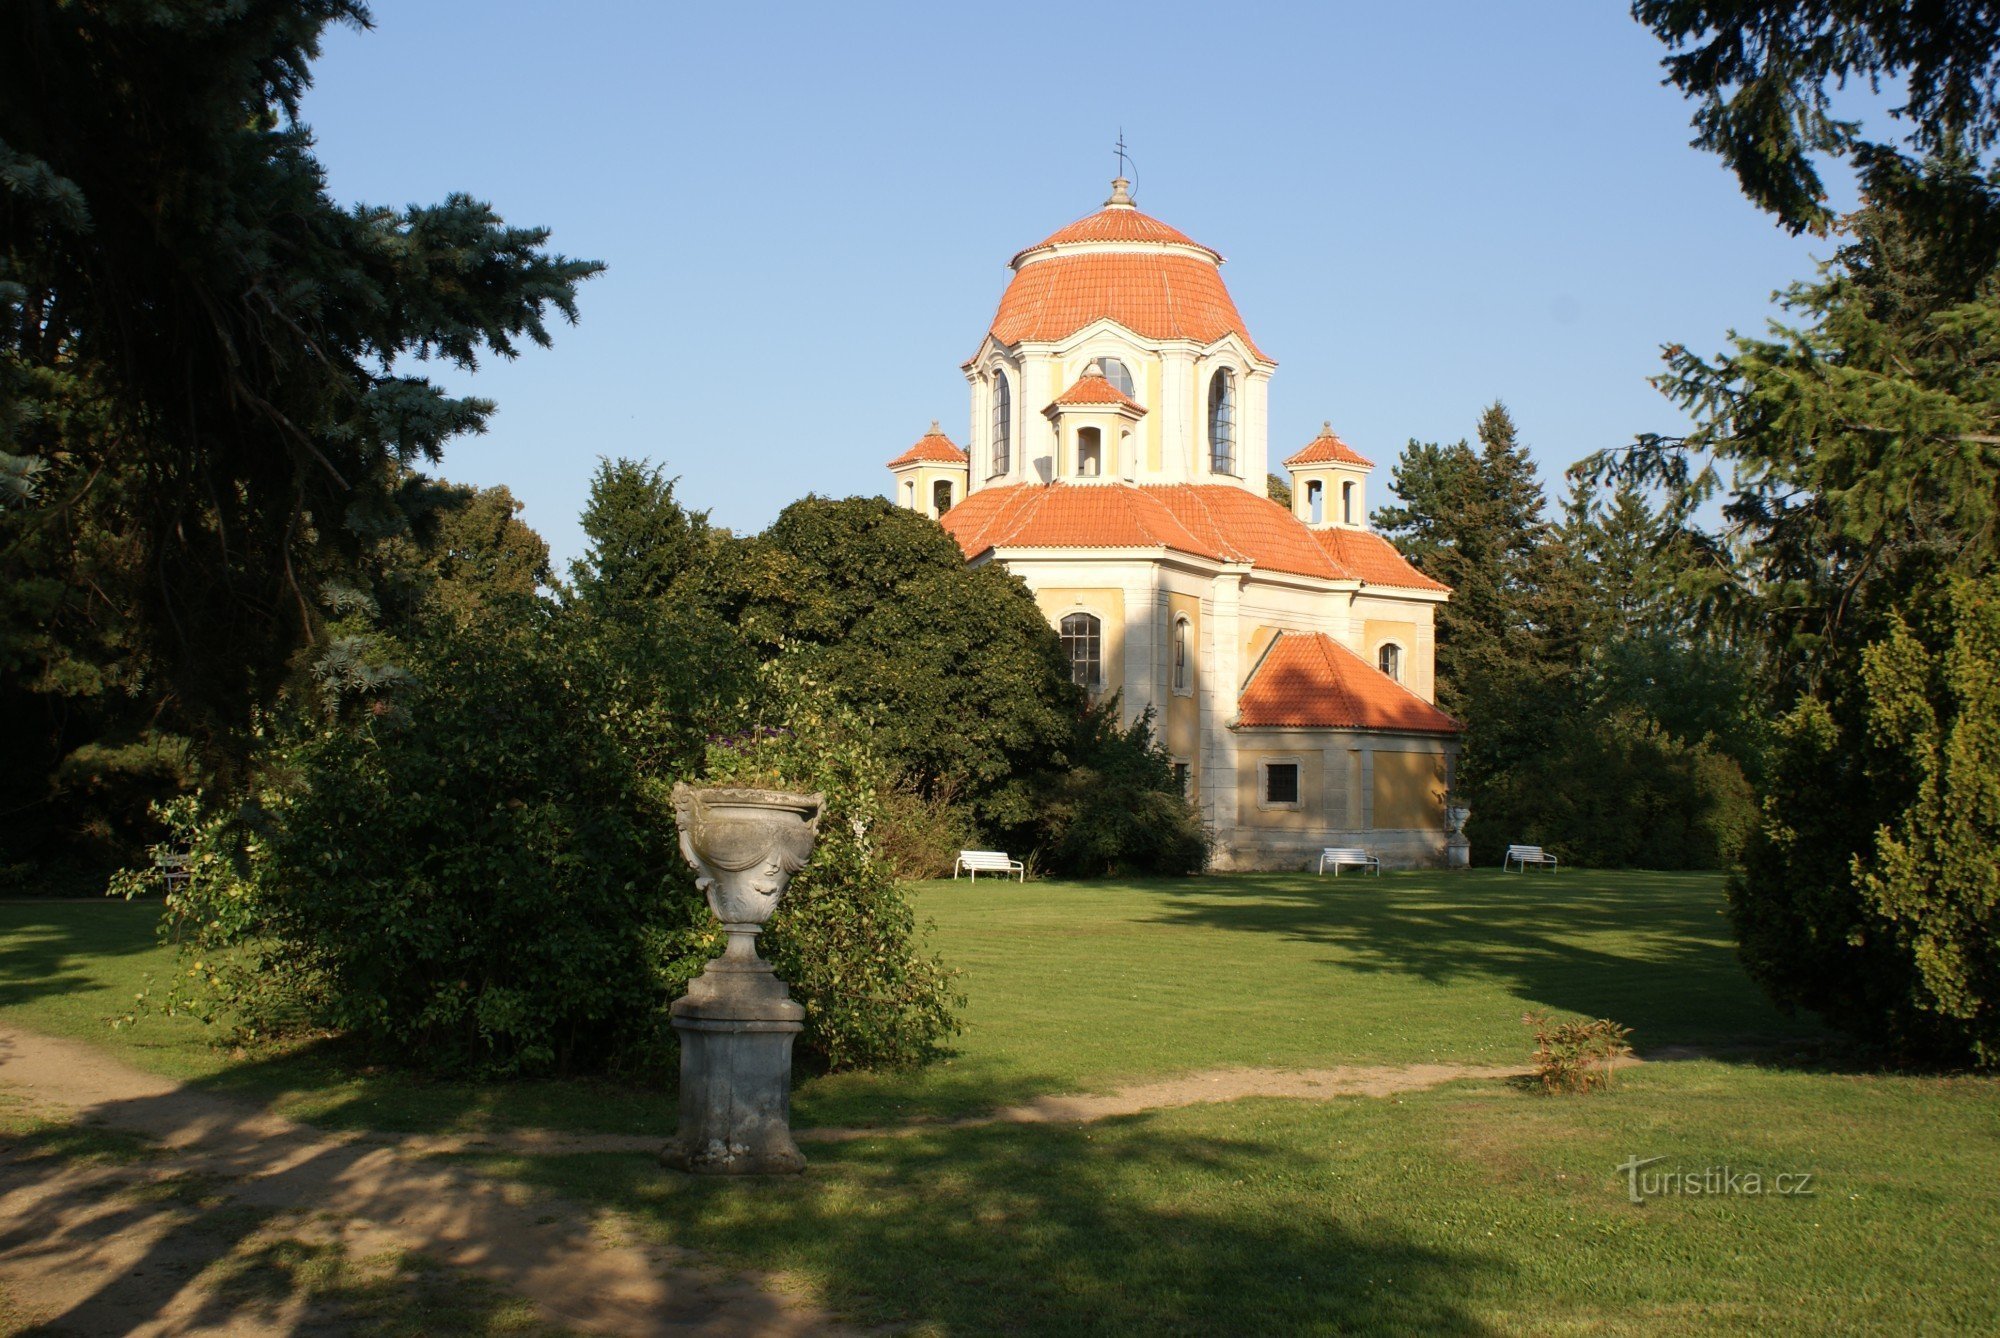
[0,1028,1528,1336]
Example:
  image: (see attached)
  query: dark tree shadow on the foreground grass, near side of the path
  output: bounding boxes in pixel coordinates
[510,1120,1512,1334]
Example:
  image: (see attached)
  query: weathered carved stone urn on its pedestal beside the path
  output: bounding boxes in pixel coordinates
[660,784,824,1176]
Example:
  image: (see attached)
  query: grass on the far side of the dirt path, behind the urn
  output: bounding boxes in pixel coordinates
[0,870,1822,1138]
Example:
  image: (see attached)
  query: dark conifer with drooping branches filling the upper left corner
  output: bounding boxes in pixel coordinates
[0,0,600,762]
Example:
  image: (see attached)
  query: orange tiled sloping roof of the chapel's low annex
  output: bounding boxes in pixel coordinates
[1236,632,1466,734]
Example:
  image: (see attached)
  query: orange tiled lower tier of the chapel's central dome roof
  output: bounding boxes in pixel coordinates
[992,250,1264,358]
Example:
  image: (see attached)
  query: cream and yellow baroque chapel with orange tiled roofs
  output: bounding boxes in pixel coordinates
[888,178,1462,870]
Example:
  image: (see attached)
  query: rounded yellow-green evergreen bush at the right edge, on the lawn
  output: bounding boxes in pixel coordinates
[1730,578,2000,1066]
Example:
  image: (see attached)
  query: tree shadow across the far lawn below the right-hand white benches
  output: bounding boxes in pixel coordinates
[1156,870,1826,1052]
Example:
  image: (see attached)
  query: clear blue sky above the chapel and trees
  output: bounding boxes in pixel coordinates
[306,0,1828,562]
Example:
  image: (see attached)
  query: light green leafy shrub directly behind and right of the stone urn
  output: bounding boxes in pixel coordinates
[704,658,964,1070]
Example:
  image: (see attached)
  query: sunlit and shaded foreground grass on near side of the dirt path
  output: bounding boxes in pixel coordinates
[480,1062,2000,1334]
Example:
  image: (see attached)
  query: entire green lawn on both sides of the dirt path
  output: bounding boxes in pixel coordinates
[0,872,2000,1334]
